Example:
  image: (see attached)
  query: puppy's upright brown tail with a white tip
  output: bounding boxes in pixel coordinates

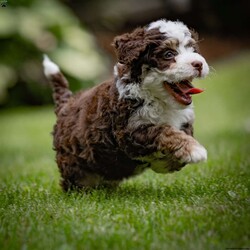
[43,55,72,115]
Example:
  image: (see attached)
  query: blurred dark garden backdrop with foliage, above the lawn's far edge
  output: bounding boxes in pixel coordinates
[0,0,250,109]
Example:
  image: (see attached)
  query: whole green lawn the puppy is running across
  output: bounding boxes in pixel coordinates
[0,54,250,250]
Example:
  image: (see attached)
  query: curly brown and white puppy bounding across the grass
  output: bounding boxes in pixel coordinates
[44,20,209,190]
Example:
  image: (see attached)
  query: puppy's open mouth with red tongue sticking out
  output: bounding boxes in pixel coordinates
[163,80,204,105]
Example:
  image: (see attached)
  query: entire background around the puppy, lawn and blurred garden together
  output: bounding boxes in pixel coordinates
[0,0,250,250]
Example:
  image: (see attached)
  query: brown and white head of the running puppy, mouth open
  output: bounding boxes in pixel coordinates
[113,20,209,106]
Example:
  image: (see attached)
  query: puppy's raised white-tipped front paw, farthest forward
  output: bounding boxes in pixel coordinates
[175,142,207,164]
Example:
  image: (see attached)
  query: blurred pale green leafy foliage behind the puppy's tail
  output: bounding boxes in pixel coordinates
[0,0,106,107]
